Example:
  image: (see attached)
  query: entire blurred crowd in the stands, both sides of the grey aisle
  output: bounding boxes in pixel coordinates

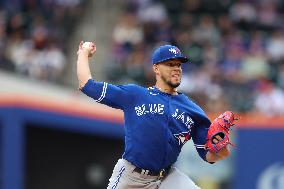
[0,0,284,115]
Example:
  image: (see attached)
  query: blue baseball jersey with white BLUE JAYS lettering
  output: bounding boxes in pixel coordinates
[81,79,211,171]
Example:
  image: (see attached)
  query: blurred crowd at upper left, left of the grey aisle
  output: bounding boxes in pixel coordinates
[0,0,83,81]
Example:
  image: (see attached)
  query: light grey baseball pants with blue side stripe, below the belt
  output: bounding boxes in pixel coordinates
[107,159,200,189]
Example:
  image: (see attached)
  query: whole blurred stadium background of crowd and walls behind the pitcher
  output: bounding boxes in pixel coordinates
[0,0,284,189]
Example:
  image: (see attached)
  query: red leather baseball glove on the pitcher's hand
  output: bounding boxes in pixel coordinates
[205,111,239,153]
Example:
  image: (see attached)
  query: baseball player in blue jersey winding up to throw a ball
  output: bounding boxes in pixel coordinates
[77,42,236,189]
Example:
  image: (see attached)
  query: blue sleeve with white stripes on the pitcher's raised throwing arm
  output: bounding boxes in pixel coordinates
[81,79,134,110]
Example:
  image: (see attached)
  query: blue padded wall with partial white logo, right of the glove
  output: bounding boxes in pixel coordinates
[233,127,284,189]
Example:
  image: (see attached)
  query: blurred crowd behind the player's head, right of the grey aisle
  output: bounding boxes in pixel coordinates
[107,0,284,115]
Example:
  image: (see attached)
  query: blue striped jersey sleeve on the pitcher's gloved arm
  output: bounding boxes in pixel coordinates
[192,113,211,161]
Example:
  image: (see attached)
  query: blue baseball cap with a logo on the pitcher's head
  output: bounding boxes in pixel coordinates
[152,45,188,64]
